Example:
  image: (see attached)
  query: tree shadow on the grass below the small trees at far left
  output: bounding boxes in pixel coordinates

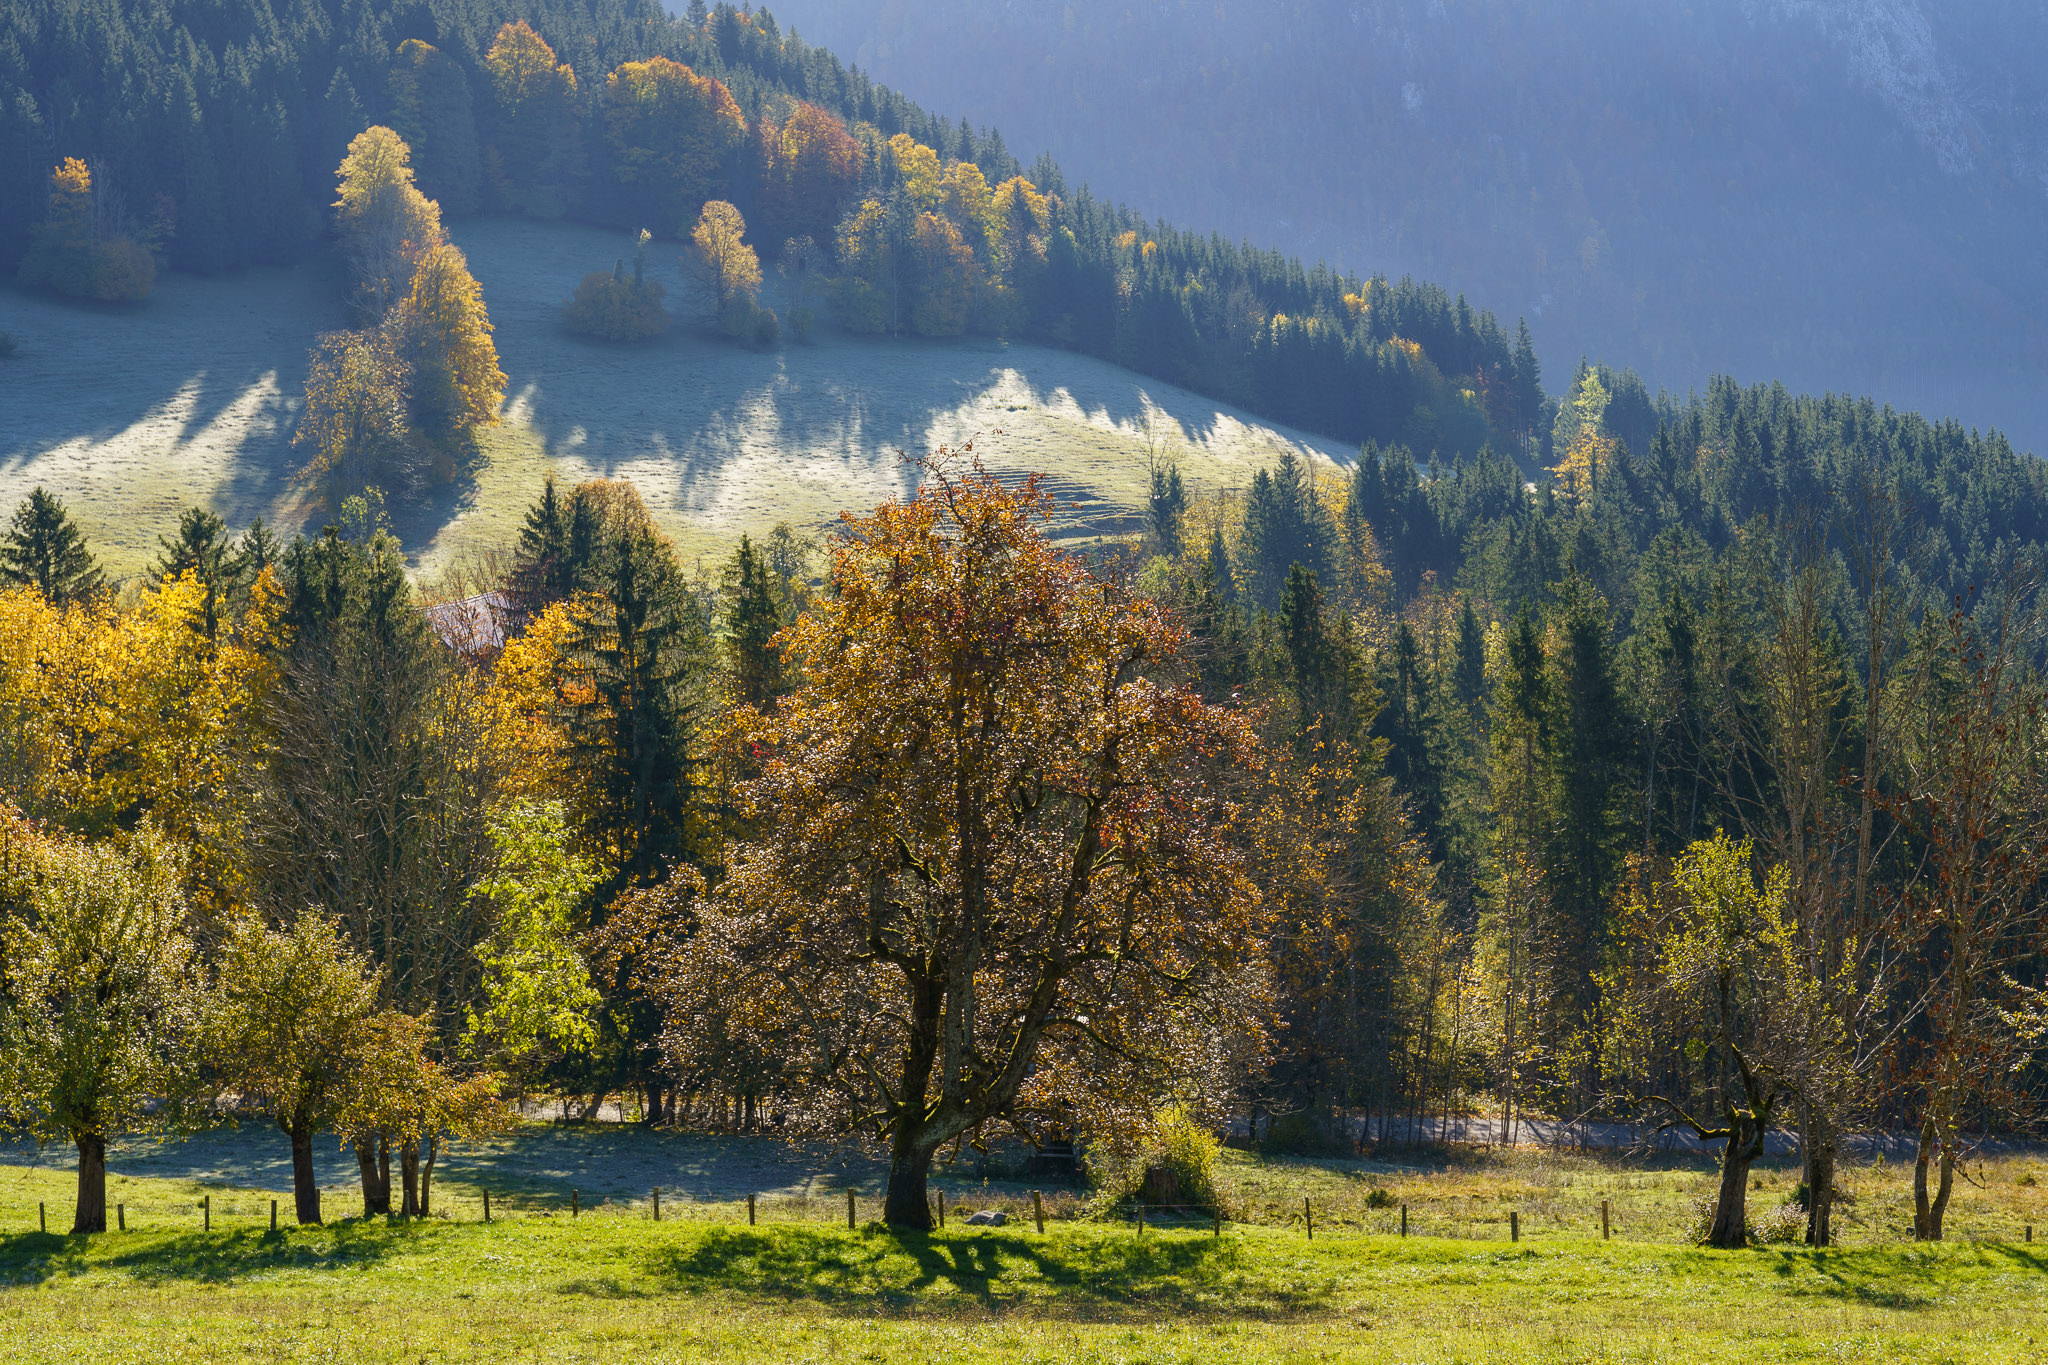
[0,1220,422,1285]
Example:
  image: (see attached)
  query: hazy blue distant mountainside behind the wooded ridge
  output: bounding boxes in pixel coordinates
[765,0,2048,450]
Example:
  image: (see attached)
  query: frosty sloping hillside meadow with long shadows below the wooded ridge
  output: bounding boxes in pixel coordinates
[0,221,1343,573]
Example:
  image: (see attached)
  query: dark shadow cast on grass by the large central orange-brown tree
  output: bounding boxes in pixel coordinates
[561,1228,1331,1318]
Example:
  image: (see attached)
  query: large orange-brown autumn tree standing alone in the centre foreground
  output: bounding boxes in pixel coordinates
[666,454,1264,1228]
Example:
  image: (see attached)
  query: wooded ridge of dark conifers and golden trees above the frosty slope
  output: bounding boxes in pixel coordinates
[0,0,1548,454]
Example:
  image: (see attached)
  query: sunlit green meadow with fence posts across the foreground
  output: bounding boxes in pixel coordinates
[0,1134,2048,1365]
